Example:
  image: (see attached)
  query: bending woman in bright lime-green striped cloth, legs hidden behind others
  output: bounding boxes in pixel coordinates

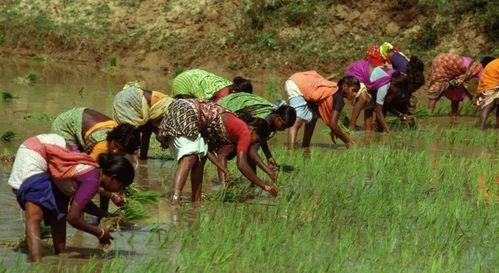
[172,69,253,101]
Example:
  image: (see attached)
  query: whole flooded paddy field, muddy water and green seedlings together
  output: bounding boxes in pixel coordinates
[0,60,499,272]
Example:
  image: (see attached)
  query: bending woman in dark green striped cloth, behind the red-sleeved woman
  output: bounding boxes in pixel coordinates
[218,93,296,172]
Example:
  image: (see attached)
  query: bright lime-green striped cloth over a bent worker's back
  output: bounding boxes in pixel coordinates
[172,69,232,100]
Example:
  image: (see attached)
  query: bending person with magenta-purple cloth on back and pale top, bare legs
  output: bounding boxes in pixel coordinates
[346,60,408,132]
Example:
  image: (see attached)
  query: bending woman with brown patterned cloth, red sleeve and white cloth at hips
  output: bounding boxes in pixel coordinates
[158,99,277,203]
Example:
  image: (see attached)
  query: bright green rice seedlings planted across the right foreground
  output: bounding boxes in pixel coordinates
[1,131,499,272]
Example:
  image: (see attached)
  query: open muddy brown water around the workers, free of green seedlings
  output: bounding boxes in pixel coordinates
[0,56,491,264]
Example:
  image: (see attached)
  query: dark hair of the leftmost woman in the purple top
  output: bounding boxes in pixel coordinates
[98,154,135,187]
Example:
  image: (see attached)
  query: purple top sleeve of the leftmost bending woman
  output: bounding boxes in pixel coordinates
[73,168,100,206]
